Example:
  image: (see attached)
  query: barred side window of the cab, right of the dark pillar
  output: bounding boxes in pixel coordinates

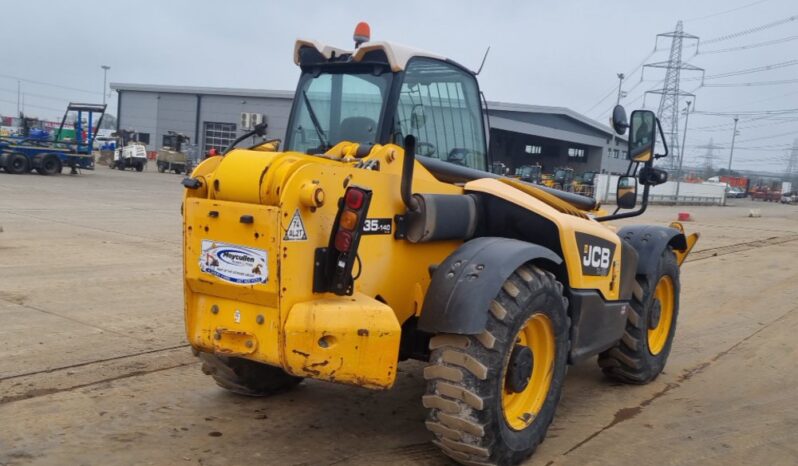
[394,58,487,170]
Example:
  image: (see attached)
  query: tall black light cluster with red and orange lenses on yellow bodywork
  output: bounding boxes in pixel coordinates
[313,186,371,295]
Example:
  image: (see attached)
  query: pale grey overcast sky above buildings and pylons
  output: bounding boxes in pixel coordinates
[0,0,798,169]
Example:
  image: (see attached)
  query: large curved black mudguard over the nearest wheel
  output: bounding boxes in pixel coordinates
[418,237,562,335]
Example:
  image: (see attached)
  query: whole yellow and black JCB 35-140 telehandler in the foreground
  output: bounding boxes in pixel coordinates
[183,23,697,464]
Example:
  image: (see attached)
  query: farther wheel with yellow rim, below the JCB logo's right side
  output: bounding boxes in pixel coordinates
[598,248,680,384]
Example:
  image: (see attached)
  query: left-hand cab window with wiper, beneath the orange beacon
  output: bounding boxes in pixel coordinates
[286,68,392,153]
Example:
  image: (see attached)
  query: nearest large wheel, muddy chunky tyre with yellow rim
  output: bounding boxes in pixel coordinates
[423,264,570,465]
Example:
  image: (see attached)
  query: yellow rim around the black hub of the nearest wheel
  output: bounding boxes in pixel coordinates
[502,314,556,430]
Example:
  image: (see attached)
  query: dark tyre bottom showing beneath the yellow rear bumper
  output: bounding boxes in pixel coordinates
[199,353,302,396]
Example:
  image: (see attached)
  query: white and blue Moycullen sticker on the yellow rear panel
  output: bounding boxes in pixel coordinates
[200,240,269,285]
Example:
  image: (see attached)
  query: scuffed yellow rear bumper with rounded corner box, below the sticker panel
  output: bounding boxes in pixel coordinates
[188,293,401,389]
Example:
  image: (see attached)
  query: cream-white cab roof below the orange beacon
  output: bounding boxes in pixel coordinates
[294,39,451,72]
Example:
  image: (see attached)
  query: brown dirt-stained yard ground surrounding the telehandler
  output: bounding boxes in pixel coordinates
[0,167,798,465]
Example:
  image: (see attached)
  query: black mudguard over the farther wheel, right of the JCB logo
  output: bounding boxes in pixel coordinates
[618,225,687,277]
